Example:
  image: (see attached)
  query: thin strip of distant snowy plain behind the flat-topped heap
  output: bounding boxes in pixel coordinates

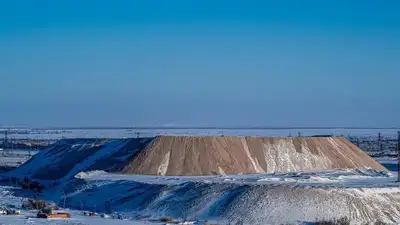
[5,129,397,139]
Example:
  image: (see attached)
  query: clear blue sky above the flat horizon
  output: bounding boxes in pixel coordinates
[0,0,400,126]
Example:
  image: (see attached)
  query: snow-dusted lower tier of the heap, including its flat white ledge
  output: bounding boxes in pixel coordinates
[59,169,400,224]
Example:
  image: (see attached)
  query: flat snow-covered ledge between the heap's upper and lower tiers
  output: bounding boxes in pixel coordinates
[75,169,400,188]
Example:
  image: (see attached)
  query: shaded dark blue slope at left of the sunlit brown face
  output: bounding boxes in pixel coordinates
[7,138,153,181]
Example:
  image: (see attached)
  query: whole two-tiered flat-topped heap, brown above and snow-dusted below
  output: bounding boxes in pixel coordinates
[0,137,400,224]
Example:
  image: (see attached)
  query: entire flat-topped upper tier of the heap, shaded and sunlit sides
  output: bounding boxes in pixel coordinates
[5,136,387,180]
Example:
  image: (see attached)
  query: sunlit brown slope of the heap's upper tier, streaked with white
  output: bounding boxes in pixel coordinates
[122,136,387,176]
